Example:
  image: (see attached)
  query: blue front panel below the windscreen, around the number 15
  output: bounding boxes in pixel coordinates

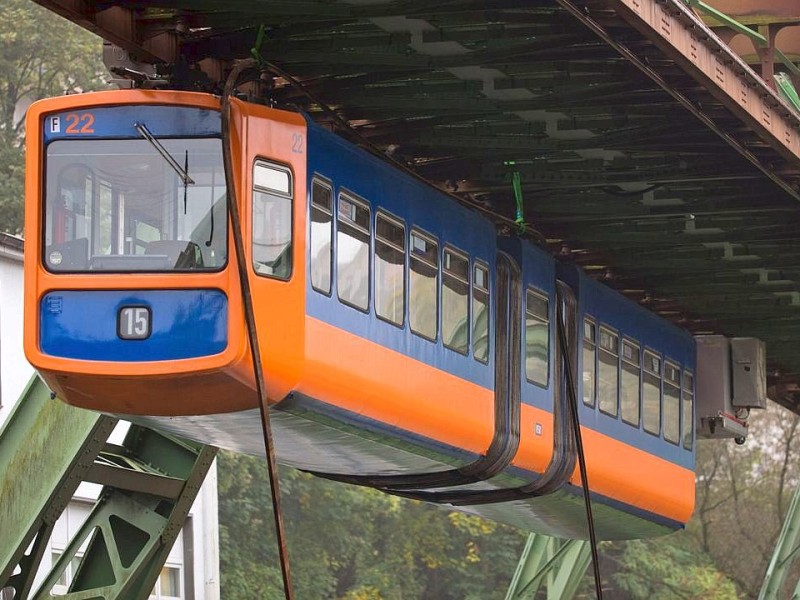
[39,290,228,362]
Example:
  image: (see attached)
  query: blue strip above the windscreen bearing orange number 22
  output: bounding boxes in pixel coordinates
[43,104,221,144]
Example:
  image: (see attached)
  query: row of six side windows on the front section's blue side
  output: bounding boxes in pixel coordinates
[309,173,489,363]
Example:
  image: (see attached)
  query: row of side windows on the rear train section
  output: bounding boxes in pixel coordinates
[582,319,694,450]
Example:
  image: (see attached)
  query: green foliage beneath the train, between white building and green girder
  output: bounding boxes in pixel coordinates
[219,453,524,600]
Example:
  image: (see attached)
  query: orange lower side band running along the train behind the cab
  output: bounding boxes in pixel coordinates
[298,317,694,522]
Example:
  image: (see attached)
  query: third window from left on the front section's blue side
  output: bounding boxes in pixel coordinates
[375,213,406,326]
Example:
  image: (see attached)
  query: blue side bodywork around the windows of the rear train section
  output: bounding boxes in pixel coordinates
[558,265,697,470]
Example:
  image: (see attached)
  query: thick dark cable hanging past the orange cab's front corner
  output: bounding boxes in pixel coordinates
[219,59,294,600]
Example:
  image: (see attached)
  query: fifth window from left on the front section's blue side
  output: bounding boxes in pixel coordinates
[442,248,470,354]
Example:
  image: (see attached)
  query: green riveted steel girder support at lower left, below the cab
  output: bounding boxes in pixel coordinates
[0,377,217,600]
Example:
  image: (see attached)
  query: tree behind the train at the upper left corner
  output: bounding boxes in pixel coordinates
[0,0,106,233]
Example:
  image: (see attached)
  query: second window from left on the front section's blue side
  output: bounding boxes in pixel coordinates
[336,194,370,311]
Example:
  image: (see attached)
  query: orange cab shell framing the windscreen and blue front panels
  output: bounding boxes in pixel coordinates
[24,90,305,414]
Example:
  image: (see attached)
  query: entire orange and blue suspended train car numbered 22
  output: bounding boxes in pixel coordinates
[25,90,695,539]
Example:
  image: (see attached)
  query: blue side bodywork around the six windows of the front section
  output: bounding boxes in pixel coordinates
[306,122,495,389]
